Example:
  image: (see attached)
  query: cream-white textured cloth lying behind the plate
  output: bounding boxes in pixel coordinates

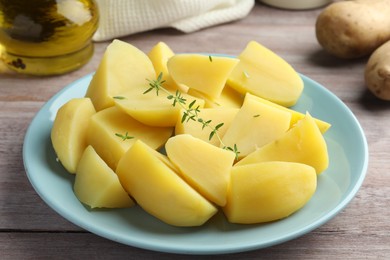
[93,0,255,41]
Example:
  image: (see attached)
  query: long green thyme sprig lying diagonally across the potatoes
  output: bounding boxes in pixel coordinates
[144,72,240,159]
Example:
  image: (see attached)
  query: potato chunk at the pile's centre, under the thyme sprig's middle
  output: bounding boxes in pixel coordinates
[175,108,239,147]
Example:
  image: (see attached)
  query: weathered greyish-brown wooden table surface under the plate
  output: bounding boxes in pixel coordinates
[0,4,390,259]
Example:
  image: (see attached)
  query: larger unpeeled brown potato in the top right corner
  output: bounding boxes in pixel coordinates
[315,0,390,59]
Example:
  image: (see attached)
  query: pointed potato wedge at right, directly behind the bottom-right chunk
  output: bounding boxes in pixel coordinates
[236,114,329,174]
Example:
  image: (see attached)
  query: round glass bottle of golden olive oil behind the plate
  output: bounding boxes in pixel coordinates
[0,0,98,75]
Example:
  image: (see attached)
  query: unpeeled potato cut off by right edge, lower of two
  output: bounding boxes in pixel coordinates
[364,41,390,101]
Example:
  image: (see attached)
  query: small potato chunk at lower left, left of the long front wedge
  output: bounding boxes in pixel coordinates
[74,146,134,208]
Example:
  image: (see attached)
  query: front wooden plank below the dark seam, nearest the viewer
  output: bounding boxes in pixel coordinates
[0,228,390,260]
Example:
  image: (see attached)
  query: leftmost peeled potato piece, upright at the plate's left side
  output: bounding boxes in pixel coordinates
[51,98,95,173]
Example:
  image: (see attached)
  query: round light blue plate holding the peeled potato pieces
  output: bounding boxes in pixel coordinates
[23,72,368,254]
